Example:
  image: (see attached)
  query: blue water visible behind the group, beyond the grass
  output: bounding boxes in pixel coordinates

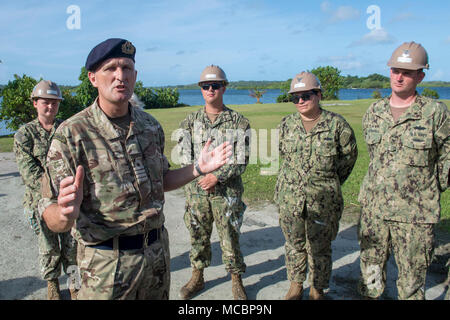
[0,87,450,136]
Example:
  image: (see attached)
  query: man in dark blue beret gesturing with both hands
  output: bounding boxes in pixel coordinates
[39,39,231,299]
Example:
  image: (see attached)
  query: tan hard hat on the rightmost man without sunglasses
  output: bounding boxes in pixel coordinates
[387,41,430,70]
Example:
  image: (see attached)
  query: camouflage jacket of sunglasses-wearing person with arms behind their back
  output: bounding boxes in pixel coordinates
[274,109,358,221]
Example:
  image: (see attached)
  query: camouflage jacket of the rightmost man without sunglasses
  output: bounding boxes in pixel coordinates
[359,95,450,223]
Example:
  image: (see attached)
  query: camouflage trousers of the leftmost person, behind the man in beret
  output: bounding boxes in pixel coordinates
[38,215,77,281]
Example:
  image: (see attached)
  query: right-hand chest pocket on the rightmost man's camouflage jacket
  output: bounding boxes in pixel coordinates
[401,130,432,167]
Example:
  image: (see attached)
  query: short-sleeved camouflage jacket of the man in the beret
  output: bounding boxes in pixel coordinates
[39,100,169,244]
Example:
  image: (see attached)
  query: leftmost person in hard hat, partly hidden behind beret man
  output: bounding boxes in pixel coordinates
[14,80,76,300]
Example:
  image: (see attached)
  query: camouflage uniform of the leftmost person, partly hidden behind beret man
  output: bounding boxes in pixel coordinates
[14,119,77,280]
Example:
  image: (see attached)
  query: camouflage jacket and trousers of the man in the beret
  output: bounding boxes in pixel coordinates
[39,100,170,299]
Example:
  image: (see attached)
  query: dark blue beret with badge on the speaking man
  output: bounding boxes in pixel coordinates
[85,38,136,71]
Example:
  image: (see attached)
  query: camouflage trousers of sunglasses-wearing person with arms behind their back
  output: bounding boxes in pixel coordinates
[279,204,339,289]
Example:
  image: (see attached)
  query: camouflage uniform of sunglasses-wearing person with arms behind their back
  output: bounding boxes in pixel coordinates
[275,109,358,289]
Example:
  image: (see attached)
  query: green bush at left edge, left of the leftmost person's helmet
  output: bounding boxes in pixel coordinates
[0,74,37,131]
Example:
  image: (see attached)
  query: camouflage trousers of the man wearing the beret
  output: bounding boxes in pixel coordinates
[77,228,170,300]
